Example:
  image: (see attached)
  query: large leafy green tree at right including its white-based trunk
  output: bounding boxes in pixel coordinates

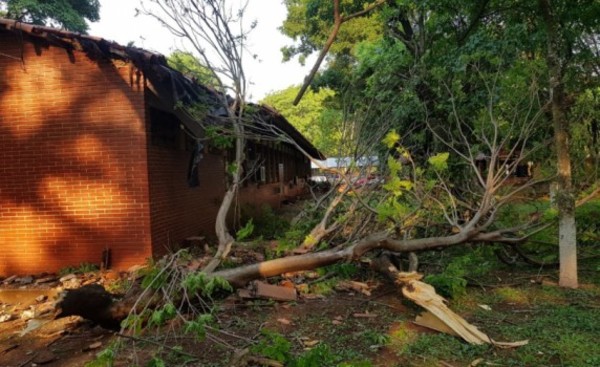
[283,0,600,287]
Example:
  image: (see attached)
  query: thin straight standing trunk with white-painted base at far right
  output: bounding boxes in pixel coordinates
[539,0,578,288]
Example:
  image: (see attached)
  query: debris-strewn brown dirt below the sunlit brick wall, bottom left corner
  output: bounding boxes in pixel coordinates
[0,273,118,367]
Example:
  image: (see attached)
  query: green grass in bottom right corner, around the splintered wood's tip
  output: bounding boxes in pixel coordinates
[388,263,600,367]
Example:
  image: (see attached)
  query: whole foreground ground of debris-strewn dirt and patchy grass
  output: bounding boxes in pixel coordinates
[0,259,600,367]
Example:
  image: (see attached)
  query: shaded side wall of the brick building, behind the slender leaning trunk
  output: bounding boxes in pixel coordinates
[147,126,312,255]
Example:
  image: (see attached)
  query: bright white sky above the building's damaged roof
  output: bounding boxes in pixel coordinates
[89,0,315,102]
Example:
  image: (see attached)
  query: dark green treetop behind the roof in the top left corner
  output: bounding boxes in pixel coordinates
[0,0,100,33]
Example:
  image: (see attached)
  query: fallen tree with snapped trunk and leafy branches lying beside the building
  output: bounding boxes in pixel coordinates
[52,1,568,366]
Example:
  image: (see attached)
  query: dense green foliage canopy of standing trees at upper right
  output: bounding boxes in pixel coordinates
[282,0,600,288]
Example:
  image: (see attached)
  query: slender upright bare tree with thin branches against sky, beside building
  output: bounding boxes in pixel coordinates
[138,0,252,273]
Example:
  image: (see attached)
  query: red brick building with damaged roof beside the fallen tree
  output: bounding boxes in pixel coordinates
[0,19,322,275]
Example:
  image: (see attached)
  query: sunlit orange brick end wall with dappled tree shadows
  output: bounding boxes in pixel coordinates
[0,32,150,275]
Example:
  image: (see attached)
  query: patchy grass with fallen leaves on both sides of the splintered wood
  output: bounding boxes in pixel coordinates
[86,259,600,367]
